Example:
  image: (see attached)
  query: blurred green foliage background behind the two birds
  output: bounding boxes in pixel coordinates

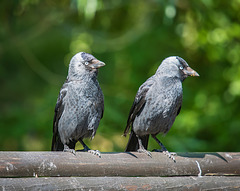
[0,0,240,152]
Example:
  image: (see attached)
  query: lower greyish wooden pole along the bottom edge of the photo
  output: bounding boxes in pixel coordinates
[0,176,240,191]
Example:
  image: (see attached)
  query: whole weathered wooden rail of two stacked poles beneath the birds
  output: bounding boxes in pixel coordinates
[0,152,240,190]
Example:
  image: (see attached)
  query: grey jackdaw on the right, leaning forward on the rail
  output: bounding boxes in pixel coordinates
[123,56,199,161]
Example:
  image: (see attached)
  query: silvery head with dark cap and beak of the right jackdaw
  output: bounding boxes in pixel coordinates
[157,56,199,81]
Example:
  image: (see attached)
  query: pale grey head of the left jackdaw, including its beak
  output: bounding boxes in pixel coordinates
[68,52,105,78]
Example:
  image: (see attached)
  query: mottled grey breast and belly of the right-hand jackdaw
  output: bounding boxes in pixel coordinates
[133,81,182,134]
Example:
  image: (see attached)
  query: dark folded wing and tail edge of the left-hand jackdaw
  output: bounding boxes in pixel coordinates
[52,80,68,151]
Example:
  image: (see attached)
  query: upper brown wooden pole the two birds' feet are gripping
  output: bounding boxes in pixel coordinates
[0,152,240,177]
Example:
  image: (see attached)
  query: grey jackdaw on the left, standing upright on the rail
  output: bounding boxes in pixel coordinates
[51,52,105,157]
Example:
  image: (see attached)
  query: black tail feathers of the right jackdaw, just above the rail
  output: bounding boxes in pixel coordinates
[125,131,149,152]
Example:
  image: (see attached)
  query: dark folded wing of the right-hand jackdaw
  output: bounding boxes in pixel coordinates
[123,76,154,136]
